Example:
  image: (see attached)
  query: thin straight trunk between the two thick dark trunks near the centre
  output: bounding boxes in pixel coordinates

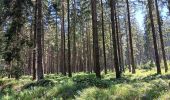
[101,0,107,74]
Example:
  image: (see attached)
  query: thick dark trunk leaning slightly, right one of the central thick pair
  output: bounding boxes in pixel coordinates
[110,0,121,78]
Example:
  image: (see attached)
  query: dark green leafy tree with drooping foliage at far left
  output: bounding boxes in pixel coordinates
[0,0,28,78]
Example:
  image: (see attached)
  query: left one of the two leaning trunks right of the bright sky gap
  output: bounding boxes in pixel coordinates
[148,0,161,74]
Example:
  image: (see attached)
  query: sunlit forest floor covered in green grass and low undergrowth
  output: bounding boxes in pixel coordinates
[0,70,170,100]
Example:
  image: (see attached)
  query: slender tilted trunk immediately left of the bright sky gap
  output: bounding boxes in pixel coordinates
[126,0,136,74]
